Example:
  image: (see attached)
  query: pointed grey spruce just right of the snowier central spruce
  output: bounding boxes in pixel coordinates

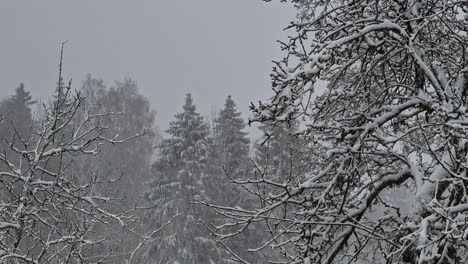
[204,96,272,263]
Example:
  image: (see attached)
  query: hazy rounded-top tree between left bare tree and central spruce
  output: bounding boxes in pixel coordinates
[74,75,159,260]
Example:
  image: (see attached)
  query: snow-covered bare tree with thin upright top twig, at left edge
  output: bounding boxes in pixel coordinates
[0,78,159,263]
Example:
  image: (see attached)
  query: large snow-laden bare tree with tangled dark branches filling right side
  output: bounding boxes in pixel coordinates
[202,0,468,263]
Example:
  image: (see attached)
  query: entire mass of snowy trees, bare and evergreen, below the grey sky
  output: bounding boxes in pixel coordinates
[0,0,468,264]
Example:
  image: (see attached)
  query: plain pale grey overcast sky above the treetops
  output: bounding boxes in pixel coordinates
[0,0,295,134]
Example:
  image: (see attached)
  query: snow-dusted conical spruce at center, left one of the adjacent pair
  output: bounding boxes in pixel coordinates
[147,94,228,264]
